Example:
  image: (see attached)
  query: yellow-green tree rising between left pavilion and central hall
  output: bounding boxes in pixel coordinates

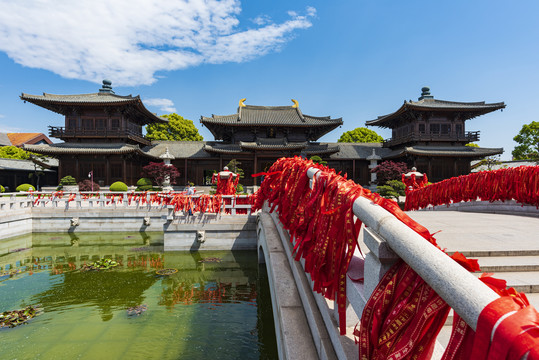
[146,113,204,141]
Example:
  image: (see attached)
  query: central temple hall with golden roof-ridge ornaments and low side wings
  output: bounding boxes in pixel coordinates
[144,99,382,186]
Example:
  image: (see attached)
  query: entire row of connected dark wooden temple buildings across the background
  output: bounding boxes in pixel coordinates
[21,80,505,185]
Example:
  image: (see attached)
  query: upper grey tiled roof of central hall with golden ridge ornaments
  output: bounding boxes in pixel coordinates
[200,105,342,127]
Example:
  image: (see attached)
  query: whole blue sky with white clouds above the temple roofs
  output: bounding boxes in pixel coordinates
[0,0,539,160]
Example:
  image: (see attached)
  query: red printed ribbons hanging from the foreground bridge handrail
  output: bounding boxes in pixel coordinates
[253,157,538,360]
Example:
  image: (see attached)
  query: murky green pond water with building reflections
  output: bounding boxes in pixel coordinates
[0,233,277,359]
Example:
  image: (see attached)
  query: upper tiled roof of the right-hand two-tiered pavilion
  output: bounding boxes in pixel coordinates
[365,98,505,128]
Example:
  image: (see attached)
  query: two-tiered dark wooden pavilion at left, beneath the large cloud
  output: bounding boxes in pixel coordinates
[21,80,167,185]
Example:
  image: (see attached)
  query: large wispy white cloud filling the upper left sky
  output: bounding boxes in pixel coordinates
[0,0,316,86]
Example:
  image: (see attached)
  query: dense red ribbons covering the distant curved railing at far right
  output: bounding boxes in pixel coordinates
[405,166,539,210]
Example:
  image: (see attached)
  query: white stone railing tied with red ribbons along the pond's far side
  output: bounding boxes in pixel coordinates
[0,191,251,216]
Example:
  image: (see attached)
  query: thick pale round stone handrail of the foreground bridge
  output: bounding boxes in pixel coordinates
[307,168,499,330]
